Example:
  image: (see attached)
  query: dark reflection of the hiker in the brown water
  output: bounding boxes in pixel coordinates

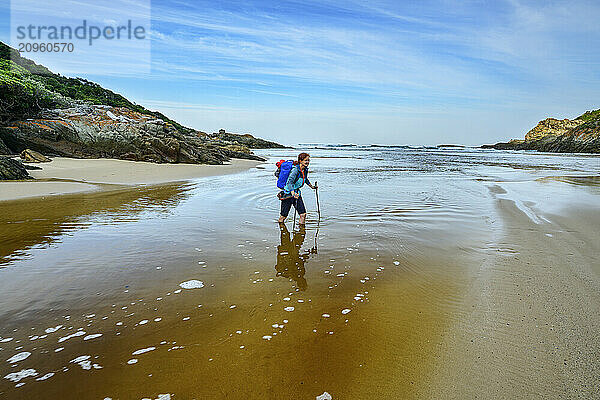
[275,224,311,290]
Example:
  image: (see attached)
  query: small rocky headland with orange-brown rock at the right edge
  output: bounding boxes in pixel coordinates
[481,110,600,153]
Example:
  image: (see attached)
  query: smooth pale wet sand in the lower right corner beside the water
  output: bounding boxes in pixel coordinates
[422,185,600,399]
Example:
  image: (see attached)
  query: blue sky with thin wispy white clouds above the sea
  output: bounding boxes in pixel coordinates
[0,0,600,145]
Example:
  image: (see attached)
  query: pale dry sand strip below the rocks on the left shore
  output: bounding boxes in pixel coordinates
[0,157,260,201]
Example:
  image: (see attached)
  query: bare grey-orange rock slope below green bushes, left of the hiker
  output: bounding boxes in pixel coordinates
[0,103,263,164]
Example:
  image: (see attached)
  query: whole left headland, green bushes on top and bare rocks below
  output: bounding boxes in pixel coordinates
[0,42,284,179]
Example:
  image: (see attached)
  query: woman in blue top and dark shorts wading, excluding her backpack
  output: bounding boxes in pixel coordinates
[279,153,317,225]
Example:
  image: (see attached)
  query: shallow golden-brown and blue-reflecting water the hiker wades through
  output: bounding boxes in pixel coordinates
[0,147,600,399]
